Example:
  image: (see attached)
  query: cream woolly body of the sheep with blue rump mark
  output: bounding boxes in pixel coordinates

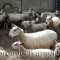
[21,30,57,48]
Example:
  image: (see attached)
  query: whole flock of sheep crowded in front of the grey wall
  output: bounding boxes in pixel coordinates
[0,5,60,60]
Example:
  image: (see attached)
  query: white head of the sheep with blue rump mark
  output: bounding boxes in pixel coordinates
[9,25,23,37]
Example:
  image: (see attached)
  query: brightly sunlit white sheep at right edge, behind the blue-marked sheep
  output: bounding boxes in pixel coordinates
[46,16,60,30]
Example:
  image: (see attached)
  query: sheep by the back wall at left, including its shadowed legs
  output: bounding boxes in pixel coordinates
[6,13,29,27]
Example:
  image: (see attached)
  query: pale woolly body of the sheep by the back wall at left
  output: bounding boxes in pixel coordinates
[8,13,29,22]
